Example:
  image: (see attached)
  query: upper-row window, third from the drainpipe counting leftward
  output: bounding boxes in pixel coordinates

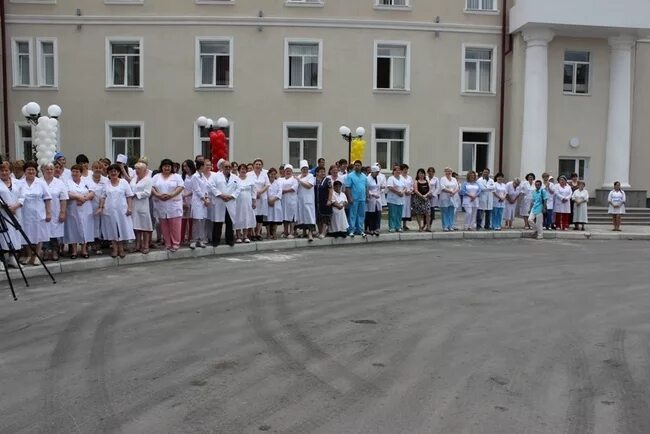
[284,40,323,89]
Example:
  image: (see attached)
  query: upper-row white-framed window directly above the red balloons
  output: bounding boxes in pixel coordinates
[196,38,232,88]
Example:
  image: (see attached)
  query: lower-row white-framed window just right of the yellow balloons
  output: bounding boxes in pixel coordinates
[370,125,408,171]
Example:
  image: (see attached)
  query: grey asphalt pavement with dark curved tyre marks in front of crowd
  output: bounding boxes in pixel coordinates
[0,239,650,434]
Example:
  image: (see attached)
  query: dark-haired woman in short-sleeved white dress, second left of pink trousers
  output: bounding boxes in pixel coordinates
[97,164,134,258]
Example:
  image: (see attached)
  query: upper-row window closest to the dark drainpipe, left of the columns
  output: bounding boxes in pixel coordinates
[462,45,496,93]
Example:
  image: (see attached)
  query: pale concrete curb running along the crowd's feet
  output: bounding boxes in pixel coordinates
[0,230,650,286]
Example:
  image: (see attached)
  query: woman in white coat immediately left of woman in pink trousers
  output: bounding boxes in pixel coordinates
[131,163,153,255]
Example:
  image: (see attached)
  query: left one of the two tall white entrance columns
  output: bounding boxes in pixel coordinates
[520,29,554,178]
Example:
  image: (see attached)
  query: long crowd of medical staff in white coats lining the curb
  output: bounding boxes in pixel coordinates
[0,152,625,266]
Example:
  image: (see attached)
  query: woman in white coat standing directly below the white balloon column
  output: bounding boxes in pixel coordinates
[41,163,68,261]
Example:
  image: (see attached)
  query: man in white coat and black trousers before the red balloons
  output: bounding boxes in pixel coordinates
[208,160,239,247]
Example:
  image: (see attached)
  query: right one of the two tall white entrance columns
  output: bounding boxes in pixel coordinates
[603,35,635,187]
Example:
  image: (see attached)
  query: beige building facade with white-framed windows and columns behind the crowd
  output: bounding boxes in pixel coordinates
[5,0,650,203]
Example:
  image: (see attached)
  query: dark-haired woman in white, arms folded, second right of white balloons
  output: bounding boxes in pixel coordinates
[63,164,96,259]
